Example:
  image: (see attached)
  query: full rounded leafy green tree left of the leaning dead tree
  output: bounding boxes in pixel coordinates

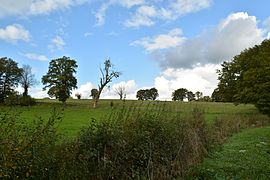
[42,56,78,103]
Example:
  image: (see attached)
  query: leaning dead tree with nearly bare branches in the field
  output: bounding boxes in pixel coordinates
[93,59,121,108]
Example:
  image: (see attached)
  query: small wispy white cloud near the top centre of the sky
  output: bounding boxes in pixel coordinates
[124,5,157,28]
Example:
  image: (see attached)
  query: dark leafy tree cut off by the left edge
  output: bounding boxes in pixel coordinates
[0,57,22,103]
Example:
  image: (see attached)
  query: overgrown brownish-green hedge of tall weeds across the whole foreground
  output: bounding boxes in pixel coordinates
[0,103,269,179]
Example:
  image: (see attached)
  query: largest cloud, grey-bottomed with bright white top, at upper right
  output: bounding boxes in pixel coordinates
[152,12,264,69]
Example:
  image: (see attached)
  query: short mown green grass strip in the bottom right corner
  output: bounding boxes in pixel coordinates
[193,126,270,179]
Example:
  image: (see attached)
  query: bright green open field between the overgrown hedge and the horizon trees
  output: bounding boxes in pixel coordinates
[0,99,263,137]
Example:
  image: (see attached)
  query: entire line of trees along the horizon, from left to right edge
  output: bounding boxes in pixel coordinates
[0,40,270,116]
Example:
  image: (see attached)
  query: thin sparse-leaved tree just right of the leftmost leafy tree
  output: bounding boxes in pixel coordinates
[20,65,37,96]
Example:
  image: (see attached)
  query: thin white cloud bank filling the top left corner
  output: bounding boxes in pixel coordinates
[0,0,86,17]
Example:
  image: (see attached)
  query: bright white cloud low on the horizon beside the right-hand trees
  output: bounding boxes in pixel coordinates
[155,64,220,100]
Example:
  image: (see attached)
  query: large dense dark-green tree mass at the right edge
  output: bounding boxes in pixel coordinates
[218,40,270,116]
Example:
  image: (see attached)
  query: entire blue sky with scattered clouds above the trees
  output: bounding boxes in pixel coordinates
[0,0,270,100]
